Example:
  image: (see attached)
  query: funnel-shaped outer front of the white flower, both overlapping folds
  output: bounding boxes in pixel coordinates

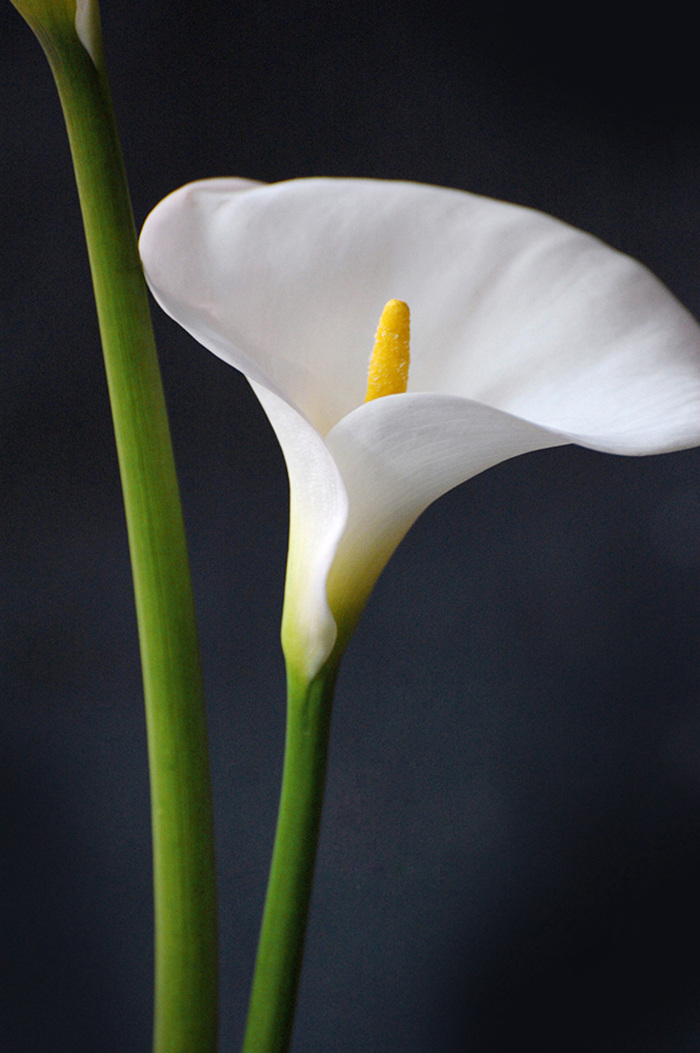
[252,381,569,678]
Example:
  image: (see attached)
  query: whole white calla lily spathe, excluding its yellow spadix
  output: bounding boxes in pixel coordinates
[140,179,700,678]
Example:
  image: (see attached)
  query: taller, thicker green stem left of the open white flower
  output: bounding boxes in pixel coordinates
[16,10,218,1053]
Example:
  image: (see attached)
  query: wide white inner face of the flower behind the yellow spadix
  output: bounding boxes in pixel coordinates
[141,179,700,453]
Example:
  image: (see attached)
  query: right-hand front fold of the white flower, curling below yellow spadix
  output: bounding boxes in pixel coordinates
[325,393,569,636]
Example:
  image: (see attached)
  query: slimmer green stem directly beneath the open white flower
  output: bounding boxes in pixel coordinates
[243,658,338,1053]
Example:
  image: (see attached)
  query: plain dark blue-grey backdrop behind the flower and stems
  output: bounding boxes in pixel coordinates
[0,0,700,1053]
